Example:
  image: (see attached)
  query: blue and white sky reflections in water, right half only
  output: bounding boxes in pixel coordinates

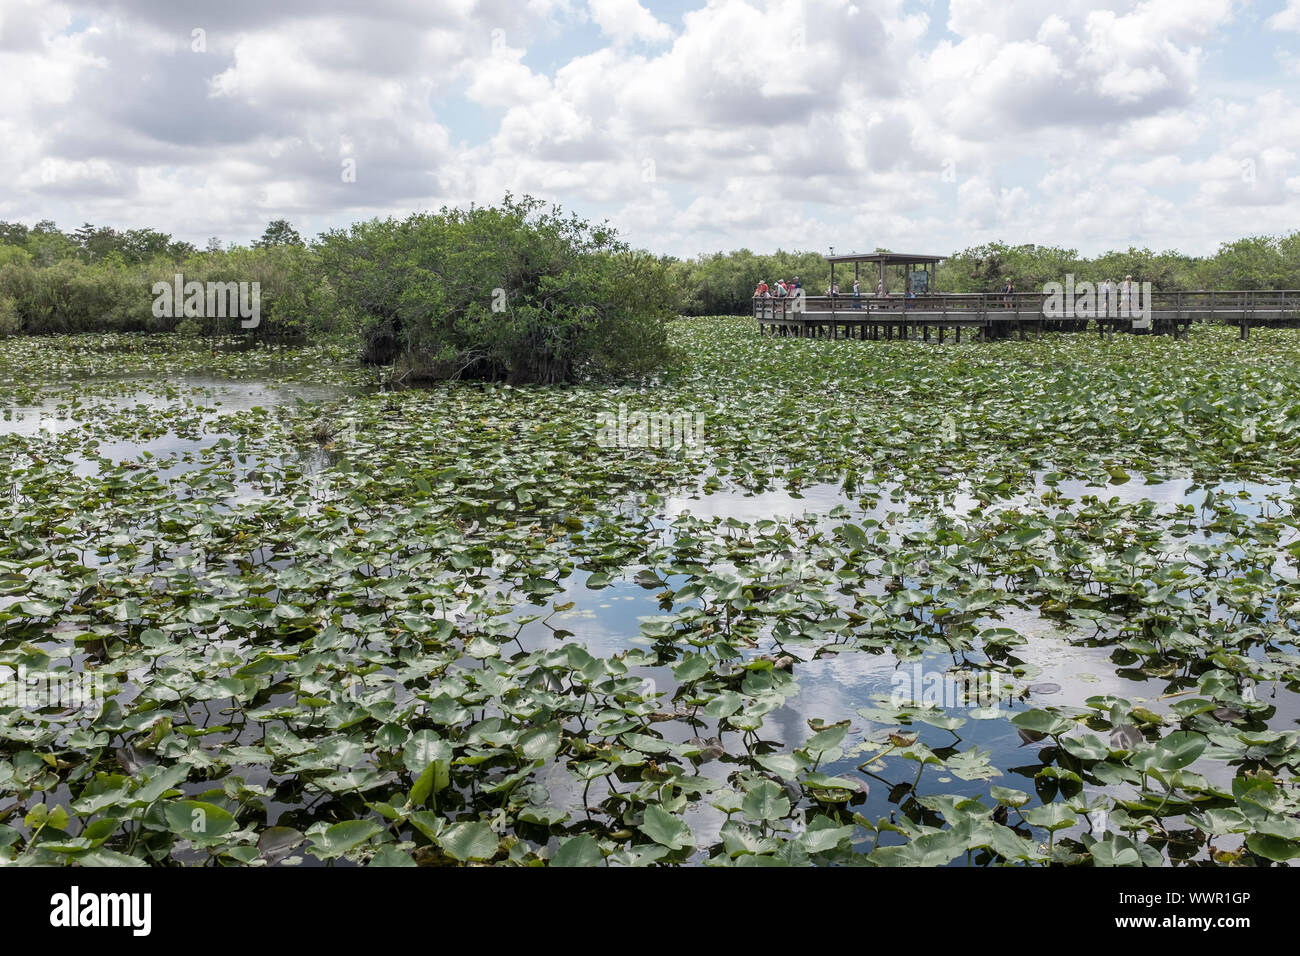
[530,476,1300,863]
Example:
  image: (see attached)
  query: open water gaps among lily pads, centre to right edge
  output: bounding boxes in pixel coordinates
[512,472,1300,849]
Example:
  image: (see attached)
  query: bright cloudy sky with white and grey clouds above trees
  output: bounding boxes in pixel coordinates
[0,0,1300,256]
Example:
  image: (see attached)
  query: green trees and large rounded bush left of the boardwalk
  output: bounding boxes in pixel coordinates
[0,196,676,384]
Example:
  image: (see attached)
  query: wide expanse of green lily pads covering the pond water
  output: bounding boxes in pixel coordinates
[0,319,1300,866]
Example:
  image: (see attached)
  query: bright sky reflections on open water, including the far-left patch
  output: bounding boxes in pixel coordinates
[10,378,1300,863]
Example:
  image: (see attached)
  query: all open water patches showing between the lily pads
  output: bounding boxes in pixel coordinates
[0,376,1300,868]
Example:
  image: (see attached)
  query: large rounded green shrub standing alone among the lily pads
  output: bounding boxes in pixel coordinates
[320,196,675,384]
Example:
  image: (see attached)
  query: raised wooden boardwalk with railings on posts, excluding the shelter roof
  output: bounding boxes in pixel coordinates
[754,290,1300,342]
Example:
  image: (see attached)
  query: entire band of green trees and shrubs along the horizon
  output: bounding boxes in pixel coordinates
[0,195,1300,374]
